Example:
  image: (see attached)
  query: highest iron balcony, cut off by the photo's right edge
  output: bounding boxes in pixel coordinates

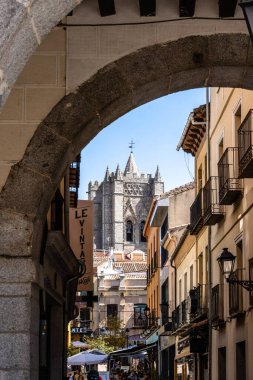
[238,109,253,178]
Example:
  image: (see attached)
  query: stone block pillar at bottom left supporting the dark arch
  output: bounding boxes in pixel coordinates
[0,257,39,380]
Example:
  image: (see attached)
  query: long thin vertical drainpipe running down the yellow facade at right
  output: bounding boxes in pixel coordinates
[206,87,212,380]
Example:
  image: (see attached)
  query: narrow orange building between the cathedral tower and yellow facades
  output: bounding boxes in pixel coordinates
[145,183,194,379]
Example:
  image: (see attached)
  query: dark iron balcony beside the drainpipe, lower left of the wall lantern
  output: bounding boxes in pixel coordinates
[211,284,225,328]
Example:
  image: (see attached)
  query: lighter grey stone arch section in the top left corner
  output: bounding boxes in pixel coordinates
[0,0,81,109]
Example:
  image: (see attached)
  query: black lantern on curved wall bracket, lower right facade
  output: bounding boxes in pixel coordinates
[217,248,253,292]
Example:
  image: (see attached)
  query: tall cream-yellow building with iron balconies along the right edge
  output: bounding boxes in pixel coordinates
[175,88,253,380]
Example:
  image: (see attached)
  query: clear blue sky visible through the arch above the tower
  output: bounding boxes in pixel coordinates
[79,89,206,199]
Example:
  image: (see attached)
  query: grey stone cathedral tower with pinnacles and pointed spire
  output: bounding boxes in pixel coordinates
[88,152,164,252]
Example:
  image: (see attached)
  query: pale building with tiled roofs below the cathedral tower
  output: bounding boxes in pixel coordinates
[93,249,147,345]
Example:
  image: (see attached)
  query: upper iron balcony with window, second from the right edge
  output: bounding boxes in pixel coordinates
[218,148,242,205]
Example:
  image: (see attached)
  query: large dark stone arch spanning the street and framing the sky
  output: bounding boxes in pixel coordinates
[0,34,253,379]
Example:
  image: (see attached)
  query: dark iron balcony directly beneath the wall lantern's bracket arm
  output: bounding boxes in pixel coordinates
[229,269,243,318]
